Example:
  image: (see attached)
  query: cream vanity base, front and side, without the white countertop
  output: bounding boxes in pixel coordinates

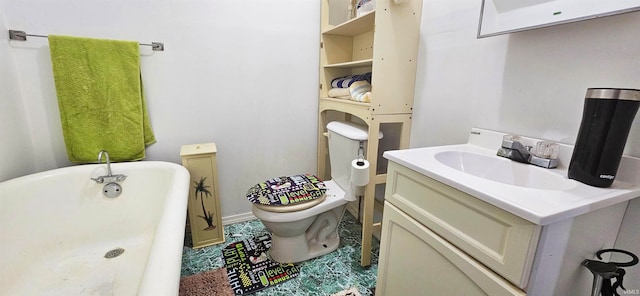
[376,156,628,296]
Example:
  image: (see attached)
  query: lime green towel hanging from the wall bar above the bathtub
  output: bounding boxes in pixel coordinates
[49,35,156,163]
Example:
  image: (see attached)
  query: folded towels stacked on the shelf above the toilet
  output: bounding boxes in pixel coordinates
[328,72,371,103]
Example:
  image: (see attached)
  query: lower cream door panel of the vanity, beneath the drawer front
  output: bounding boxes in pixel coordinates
[376,202,526,296]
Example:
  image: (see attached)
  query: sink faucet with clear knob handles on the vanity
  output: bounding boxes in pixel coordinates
[498,135,558,169]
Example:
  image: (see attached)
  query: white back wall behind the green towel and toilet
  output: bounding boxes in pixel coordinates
[0,0,320,217]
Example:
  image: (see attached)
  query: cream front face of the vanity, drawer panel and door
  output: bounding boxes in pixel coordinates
[376,162,541,295]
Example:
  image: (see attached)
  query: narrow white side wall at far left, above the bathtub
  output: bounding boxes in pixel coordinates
[0,2,35,182]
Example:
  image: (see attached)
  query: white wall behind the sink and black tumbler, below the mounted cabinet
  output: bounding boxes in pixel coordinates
[411,0,640,289]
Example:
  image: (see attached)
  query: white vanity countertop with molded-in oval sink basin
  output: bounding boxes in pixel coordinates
[383,128,640,225]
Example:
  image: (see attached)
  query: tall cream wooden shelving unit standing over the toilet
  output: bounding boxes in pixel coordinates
[318,0,422,266]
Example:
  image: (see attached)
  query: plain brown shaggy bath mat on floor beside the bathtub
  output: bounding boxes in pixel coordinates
[178,267,235,296]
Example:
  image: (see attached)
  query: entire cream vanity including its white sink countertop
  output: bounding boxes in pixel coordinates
[376,128,640,296]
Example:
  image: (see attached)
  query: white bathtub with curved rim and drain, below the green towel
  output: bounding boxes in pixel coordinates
[0,161,190,296]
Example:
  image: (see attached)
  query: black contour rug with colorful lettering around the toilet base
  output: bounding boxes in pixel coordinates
[222,234,300,295]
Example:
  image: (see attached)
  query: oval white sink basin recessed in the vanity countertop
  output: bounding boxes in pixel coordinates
[434,151,575,190]
